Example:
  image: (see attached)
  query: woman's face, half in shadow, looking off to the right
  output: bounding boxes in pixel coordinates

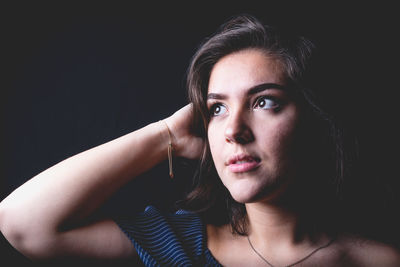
[207,49,300,203]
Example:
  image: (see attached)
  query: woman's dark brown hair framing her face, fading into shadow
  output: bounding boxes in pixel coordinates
[180,14,356,234]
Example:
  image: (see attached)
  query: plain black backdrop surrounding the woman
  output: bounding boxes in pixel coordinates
[0,1,399,266]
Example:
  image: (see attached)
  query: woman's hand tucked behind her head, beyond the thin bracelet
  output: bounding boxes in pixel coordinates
[164,104,204,159]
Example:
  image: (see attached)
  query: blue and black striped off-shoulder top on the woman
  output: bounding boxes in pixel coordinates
[116,206,222,266]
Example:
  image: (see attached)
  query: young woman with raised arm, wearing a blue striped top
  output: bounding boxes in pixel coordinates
[0,15,400,266]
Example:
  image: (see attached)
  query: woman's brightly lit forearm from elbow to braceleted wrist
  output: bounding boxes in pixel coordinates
[0,121,169,235]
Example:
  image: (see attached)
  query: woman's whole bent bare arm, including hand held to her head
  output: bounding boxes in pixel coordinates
[0,105,202,259]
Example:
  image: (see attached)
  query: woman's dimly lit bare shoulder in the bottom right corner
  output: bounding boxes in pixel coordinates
[337,234,400,267]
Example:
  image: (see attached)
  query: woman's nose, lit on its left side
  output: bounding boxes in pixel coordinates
[225,112,254,144]
